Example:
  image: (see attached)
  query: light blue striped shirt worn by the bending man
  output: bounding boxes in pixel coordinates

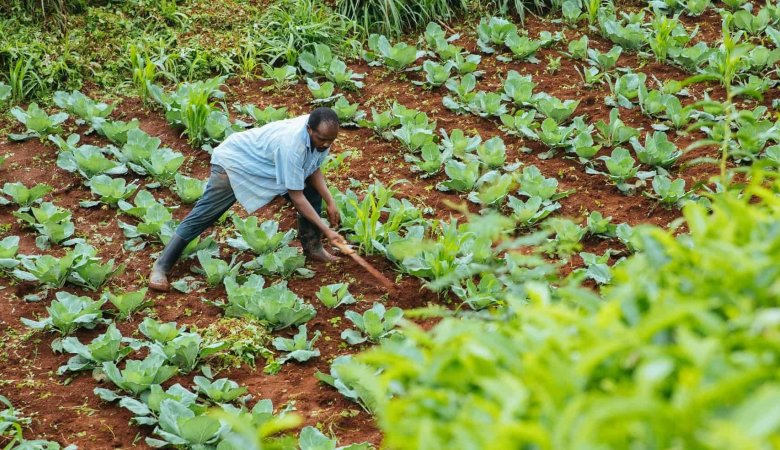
[211,114,328,214]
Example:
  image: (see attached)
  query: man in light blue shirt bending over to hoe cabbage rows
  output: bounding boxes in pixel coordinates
[149,108,344,291]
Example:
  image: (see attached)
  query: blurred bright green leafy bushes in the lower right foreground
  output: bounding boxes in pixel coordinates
[353,175,780,449]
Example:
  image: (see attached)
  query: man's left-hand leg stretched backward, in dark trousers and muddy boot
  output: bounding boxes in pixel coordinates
[149,165,236,291]
